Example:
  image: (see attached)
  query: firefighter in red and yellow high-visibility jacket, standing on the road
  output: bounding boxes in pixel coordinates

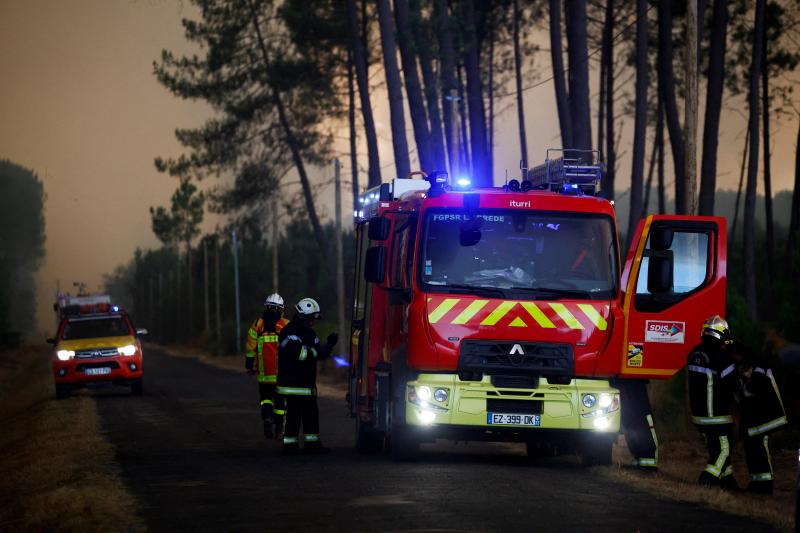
[245,293,287,439]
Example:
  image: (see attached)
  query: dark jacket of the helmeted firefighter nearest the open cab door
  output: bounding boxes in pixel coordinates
[686,340,733,426]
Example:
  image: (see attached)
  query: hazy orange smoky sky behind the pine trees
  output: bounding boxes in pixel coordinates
[0,0,797,330]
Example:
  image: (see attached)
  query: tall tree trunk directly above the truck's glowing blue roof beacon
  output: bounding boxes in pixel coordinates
[433,0,461,173]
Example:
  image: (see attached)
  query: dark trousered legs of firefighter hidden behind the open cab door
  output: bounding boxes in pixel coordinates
[614,379,658,468]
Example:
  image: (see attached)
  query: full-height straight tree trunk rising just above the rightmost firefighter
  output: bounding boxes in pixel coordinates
[743,0,766,320]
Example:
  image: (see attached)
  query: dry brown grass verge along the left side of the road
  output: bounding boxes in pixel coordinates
[0,348,144,531]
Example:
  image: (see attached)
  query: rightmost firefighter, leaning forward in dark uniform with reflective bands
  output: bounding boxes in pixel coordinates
[723,343,787,494]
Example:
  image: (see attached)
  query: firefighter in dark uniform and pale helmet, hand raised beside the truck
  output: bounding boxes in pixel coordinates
[278,298,339,455]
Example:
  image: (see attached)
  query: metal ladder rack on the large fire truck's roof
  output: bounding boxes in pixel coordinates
[527,148,605,194]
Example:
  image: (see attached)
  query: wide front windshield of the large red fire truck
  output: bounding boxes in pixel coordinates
[419,210,617,299]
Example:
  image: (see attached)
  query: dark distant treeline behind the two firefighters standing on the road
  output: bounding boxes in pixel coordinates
[105,219,355,353]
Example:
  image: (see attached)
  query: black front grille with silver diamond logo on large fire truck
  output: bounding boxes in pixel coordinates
[458,341,575,376]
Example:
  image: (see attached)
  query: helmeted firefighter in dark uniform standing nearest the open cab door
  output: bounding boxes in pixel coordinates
[686,315,737,489]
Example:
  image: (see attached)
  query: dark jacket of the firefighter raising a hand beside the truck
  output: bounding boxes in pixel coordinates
[278,319,331,396]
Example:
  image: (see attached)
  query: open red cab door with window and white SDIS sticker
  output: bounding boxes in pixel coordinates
[620,215,727,379]
